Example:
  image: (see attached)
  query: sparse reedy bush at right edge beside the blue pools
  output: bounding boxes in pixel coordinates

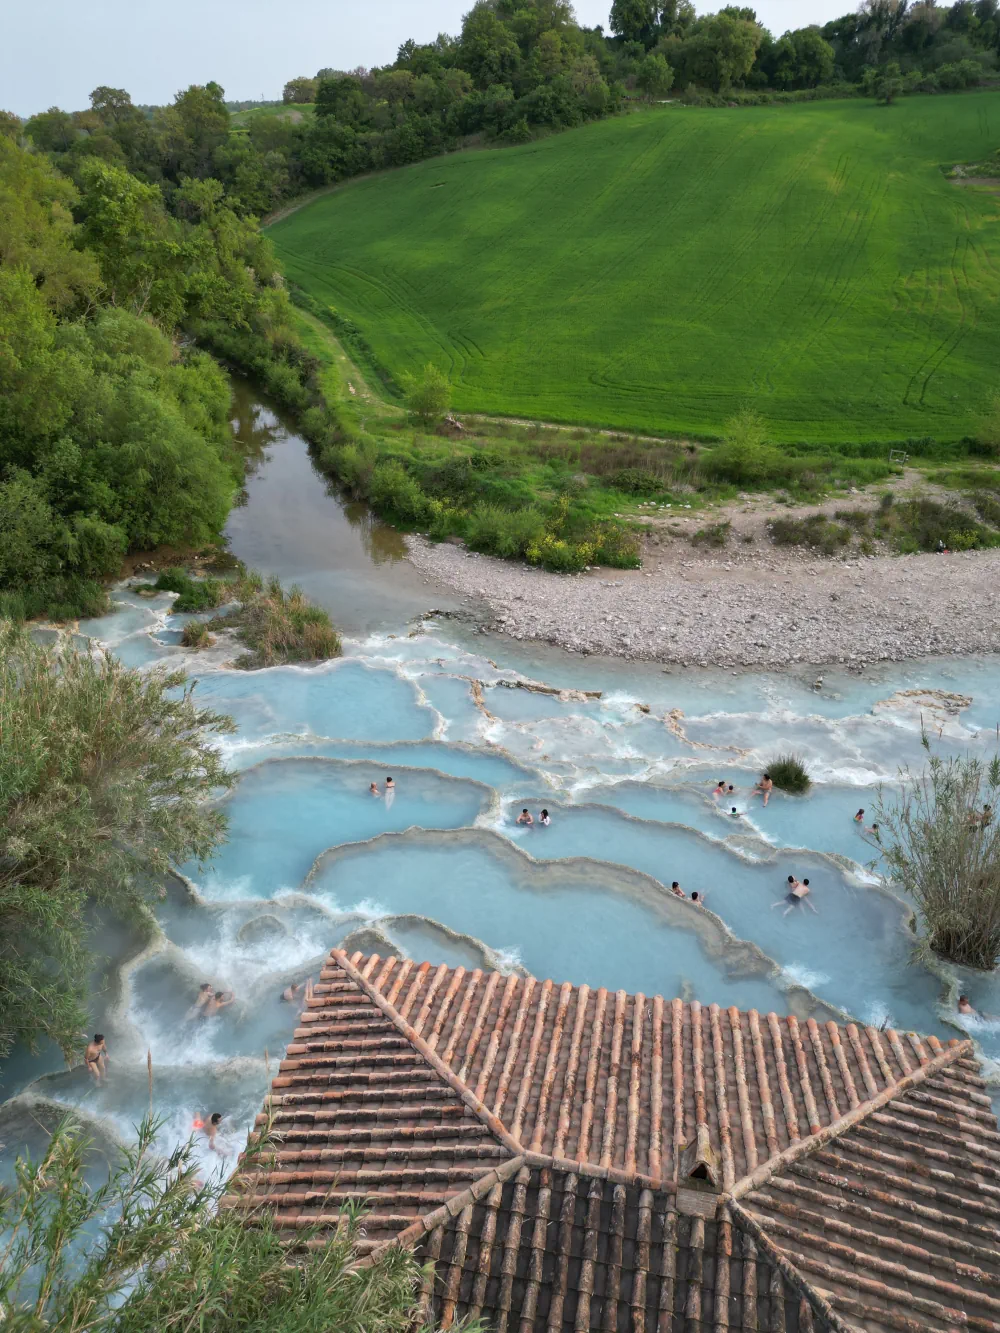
[871,738,1000,969]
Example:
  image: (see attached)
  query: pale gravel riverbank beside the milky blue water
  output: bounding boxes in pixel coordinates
[409,537,1000,668]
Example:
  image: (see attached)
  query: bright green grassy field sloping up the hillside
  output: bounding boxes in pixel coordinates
[271,92,1000,441]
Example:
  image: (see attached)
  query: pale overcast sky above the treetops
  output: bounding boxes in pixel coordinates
[0,0,853,116]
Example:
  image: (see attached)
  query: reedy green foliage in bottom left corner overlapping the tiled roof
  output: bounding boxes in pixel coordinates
[0,1120,459,1333]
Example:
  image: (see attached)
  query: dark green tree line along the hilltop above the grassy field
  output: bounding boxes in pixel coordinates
[11,0,1000,234]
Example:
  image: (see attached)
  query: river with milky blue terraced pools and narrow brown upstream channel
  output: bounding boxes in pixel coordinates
[0,384,1000,1172]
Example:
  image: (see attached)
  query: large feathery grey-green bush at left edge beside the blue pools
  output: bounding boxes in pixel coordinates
[0,621,235,1061]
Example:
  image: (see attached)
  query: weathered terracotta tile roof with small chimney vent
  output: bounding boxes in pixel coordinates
[234,950,1000,1333]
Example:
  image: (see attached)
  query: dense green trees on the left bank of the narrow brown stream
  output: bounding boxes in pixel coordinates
[0,103,314,619]
